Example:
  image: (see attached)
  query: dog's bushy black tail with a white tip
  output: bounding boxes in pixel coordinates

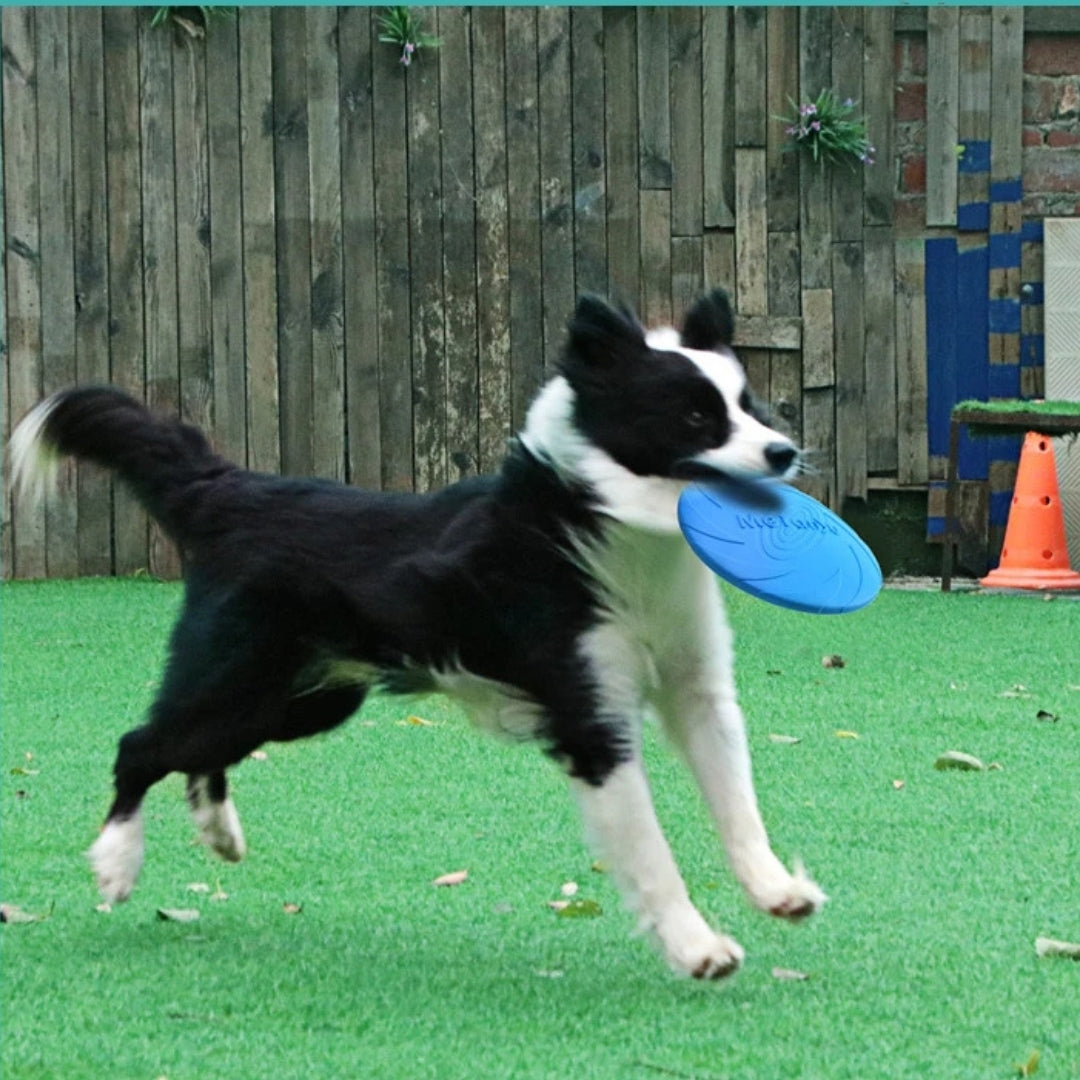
[10,387,235,539]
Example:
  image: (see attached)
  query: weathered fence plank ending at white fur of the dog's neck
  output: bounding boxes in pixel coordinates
[505,8,543,429]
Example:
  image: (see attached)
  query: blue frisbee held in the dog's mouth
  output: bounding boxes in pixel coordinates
[678,483,881,615]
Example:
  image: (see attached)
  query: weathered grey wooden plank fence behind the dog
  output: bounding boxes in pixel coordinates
[0,6,1067,578]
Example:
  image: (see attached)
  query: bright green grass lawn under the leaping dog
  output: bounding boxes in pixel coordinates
[0,581,1080,1080]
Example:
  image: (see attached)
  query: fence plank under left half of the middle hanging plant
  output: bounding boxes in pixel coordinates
[369,12,416,491]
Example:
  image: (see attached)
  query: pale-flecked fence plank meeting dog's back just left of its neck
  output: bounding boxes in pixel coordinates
[472,8,513,473]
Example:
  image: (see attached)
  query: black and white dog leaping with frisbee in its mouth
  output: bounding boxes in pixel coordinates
[11,291,825,978]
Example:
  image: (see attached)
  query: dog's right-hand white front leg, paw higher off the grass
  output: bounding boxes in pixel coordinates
[662,686,825,919]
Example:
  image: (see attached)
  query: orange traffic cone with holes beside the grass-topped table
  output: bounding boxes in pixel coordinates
[978,431,1080,589]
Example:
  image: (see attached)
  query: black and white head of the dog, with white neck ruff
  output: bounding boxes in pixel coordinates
[525,289,799,527]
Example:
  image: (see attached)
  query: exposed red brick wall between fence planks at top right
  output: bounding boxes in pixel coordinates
[893,31,1080,228]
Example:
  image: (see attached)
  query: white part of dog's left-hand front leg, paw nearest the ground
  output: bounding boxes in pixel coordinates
[571,756,743,978]
